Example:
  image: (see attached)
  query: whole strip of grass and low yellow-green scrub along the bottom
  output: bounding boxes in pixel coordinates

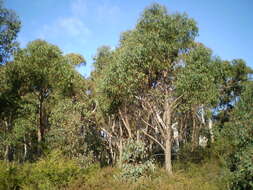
[0,152,228,190]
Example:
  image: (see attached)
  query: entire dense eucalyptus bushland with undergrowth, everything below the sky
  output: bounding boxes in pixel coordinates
[0,1,253,190]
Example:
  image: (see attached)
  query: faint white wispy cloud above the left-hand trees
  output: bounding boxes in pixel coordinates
[35,0,120,49]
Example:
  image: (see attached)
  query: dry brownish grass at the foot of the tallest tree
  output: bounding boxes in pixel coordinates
[68,162,225,190]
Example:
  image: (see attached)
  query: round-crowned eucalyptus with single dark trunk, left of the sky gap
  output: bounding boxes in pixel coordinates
[2,40,84,158]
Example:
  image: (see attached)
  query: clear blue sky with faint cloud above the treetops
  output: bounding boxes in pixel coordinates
[5,0,253,76]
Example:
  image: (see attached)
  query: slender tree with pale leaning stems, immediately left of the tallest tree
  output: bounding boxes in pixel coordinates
[91,46,127,166]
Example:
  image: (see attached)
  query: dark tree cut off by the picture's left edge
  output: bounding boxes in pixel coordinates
[0,0,21,158]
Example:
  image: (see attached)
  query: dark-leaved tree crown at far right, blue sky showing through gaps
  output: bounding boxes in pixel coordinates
[214,59,253,127]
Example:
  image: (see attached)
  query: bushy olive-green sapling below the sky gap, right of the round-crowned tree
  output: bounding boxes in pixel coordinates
[46,99,105,166]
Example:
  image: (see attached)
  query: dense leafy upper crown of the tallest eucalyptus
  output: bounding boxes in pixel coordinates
[97,4,198,113]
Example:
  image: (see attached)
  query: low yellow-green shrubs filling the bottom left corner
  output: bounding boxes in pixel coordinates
[0,151,84,190]
